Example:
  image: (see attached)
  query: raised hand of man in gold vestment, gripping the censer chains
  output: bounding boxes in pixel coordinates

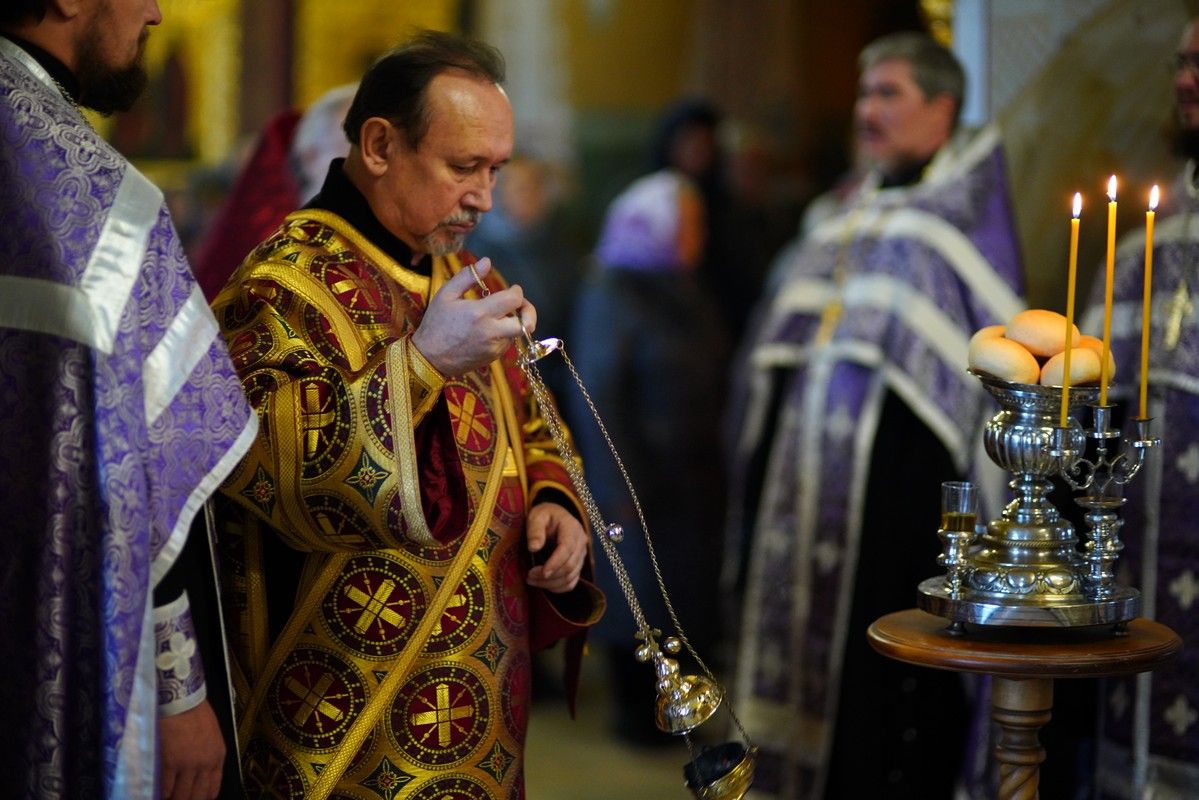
[412,258,537,377]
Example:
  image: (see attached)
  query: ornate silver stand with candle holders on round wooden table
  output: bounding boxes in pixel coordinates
[917,373,1161,632]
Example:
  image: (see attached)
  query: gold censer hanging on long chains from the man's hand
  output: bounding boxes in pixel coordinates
[470,264,758,800]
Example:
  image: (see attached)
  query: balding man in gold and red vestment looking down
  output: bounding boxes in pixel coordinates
[215,34,603,800]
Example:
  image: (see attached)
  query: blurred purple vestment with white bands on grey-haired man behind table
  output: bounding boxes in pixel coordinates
[734,130,1023,798]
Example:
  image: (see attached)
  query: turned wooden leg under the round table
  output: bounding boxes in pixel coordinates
[990,675,1053,800]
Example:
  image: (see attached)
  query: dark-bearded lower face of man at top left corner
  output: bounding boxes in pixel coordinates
[73,0,162,114]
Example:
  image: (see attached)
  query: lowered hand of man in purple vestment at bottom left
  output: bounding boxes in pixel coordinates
[158,700,225,800]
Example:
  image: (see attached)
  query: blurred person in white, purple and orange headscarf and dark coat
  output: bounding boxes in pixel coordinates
[567,110,728,744]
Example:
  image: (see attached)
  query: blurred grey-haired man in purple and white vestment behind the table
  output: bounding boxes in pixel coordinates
[723,32,1023,800]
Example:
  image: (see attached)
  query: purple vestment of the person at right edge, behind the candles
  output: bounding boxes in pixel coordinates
[1083,162,1199,799]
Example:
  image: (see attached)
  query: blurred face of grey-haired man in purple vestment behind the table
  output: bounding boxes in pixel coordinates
[854,59,953,174]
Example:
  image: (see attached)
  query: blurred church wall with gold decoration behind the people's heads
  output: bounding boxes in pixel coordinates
[97,0,1197,319]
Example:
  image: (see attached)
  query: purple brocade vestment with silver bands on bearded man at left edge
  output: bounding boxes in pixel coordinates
[0,38,257,799]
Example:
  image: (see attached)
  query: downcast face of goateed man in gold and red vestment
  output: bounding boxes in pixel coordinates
[380,72,513,255]
